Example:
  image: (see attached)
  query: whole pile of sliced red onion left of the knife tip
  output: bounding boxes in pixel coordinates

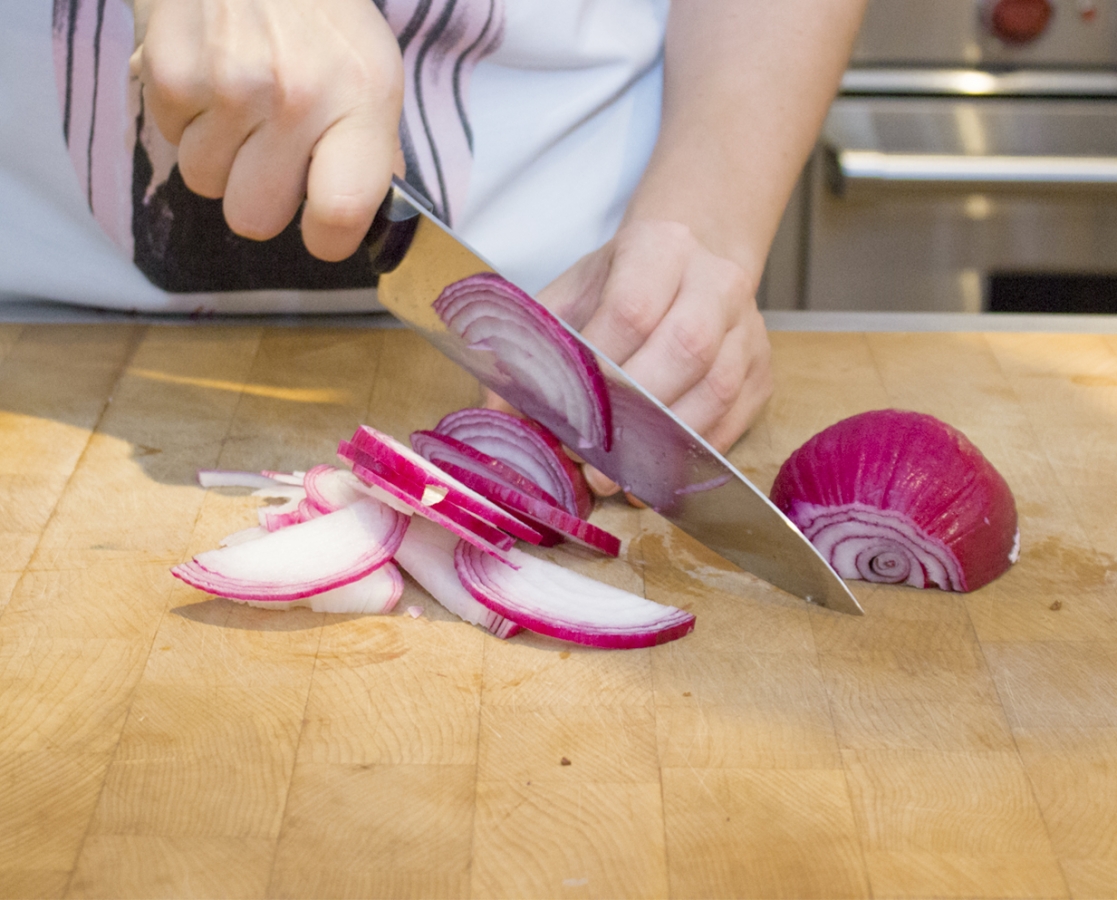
[172,409,695,648]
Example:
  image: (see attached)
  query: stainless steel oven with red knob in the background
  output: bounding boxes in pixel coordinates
[762,0,1117,312]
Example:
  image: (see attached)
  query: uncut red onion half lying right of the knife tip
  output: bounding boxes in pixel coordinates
[772,410,1020,591]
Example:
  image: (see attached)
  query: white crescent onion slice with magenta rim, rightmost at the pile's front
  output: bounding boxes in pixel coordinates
[454,543,695,648]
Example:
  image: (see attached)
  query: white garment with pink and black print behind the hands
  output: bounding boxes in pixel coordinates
[0,0,669,313]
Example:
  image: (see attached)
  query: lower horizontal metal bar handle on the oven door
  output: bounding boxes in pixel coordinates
[825,146,1117,197]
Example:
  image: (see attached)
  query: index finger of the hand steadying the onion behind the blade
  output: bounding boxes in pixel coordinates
[582,223,690,365]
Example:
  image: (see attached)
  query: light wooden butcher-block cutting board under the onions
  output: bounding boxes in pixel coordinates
[0,325,1117,898]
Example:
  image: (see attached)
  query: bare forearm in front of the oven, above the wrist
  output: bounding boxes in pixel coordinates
[627,0,866,279]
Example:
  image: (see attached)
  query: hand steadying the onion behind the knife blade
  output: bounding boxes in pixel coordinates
[538,220,772,495]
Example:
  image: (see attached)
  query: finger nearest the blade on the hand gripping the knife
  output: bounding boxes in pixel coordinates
[303,117,398,261]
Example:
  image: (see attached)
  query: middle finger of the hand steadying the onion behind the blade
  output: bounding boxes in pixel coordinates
[624,253,751,405]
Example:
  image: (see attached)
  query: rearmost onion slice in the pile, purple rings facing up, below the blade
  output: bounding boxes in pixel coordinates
[435,409,593,519]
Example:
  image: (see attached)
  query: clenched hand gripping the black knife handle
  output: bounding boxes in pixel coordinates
[132,0,403,261]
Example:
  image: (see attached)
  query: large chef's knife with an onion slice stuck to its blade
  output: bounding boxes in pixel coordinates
[367,180,861,614]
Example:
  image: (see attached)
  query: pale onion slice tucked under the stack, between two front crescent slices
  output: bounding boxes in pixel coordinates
[395,517,521,638]
